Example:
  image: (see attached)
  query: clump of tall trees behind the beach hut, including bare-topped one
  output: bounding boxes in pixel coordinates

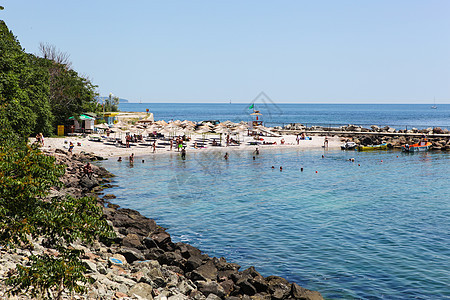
[0,20,102,136]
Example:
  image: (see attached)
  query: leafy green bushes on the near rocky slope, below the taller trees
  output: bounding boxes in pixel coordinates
[0,140,113,299]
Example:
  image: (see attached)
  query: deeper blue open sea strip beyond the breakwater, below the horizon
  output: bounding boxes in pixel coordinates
[119,103,450,129]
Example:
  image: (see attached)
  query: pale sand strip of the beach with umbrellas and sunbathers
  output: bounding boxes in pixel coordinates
[37,134,342,158]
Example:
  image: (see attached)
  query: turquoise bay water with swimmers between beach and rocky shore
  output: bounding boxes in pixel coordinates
[102,148,450,299]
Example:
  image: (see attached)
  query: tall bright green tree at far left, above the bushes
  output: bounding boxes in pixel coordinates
[0,20,53,136]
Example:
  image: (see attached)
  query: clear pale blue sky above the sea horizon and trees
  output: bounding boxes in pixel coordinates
[0,0,450,104]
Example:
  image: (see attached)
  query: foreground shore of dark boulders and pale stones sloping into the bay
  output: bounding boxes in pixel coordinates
[0,150,323,300]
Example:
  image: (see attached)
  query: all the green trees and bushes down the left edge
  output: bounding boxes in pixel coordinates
[0,20,116,299]
